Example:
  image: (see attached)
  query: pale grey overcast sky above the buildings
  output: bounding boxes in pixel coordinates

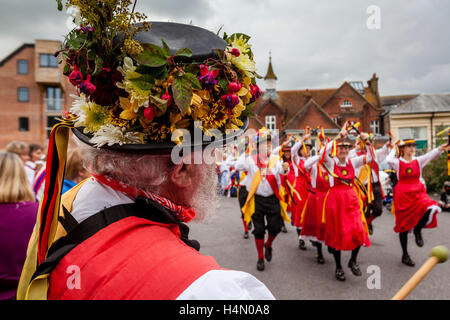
[0,0,450,95]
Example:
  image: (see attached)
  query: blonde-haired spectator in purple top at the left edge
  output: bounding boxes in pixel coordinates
[0,151,38,300]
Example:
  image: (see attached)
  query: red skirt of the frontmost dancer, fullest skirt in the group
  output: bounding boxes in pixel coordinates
[324,185,370,251]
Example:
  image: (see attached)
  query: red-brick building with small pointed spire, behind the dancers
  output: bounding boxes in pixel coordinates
[250,59,384,148]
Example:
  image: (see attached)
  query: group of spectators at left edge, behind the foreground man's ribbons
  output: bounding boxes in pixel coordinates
[0,141,89,300]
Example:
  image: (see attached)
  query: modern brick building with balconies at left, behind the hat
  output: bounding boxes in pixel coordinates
[0,40,75,149]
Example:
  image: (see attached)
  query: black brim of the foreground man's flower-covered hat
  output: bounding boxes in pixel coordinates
[72,117,250,154]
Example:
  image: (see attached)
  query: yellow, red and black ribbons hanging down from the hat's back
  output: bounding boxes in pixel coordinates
[17,115,76,300]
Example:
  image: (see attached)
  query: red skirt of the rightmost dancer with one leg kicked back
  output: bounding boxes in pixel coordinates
[393,182,439,232]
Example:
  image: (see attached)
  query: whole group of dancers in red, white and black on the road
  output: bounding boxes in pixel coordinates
[218,123,450,281]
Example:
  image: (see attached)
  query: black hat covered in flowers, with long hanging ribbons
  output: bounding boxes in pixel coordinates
[14,0,261,298]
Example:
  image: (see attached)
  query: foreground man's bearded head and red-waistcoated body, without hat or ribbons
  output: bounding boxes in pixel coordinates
[30,140,273,300]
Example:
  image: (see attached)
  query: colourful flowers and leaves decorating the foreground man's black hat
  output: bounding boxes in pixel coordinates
[57,0,261,147]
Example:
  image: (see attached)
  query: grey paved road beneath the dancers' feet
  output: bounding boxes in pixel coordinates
[191,197,450,300]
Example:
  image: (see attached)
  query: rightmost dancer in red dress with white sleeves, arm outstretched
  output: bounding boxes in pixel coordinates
[386,139,450,267]
